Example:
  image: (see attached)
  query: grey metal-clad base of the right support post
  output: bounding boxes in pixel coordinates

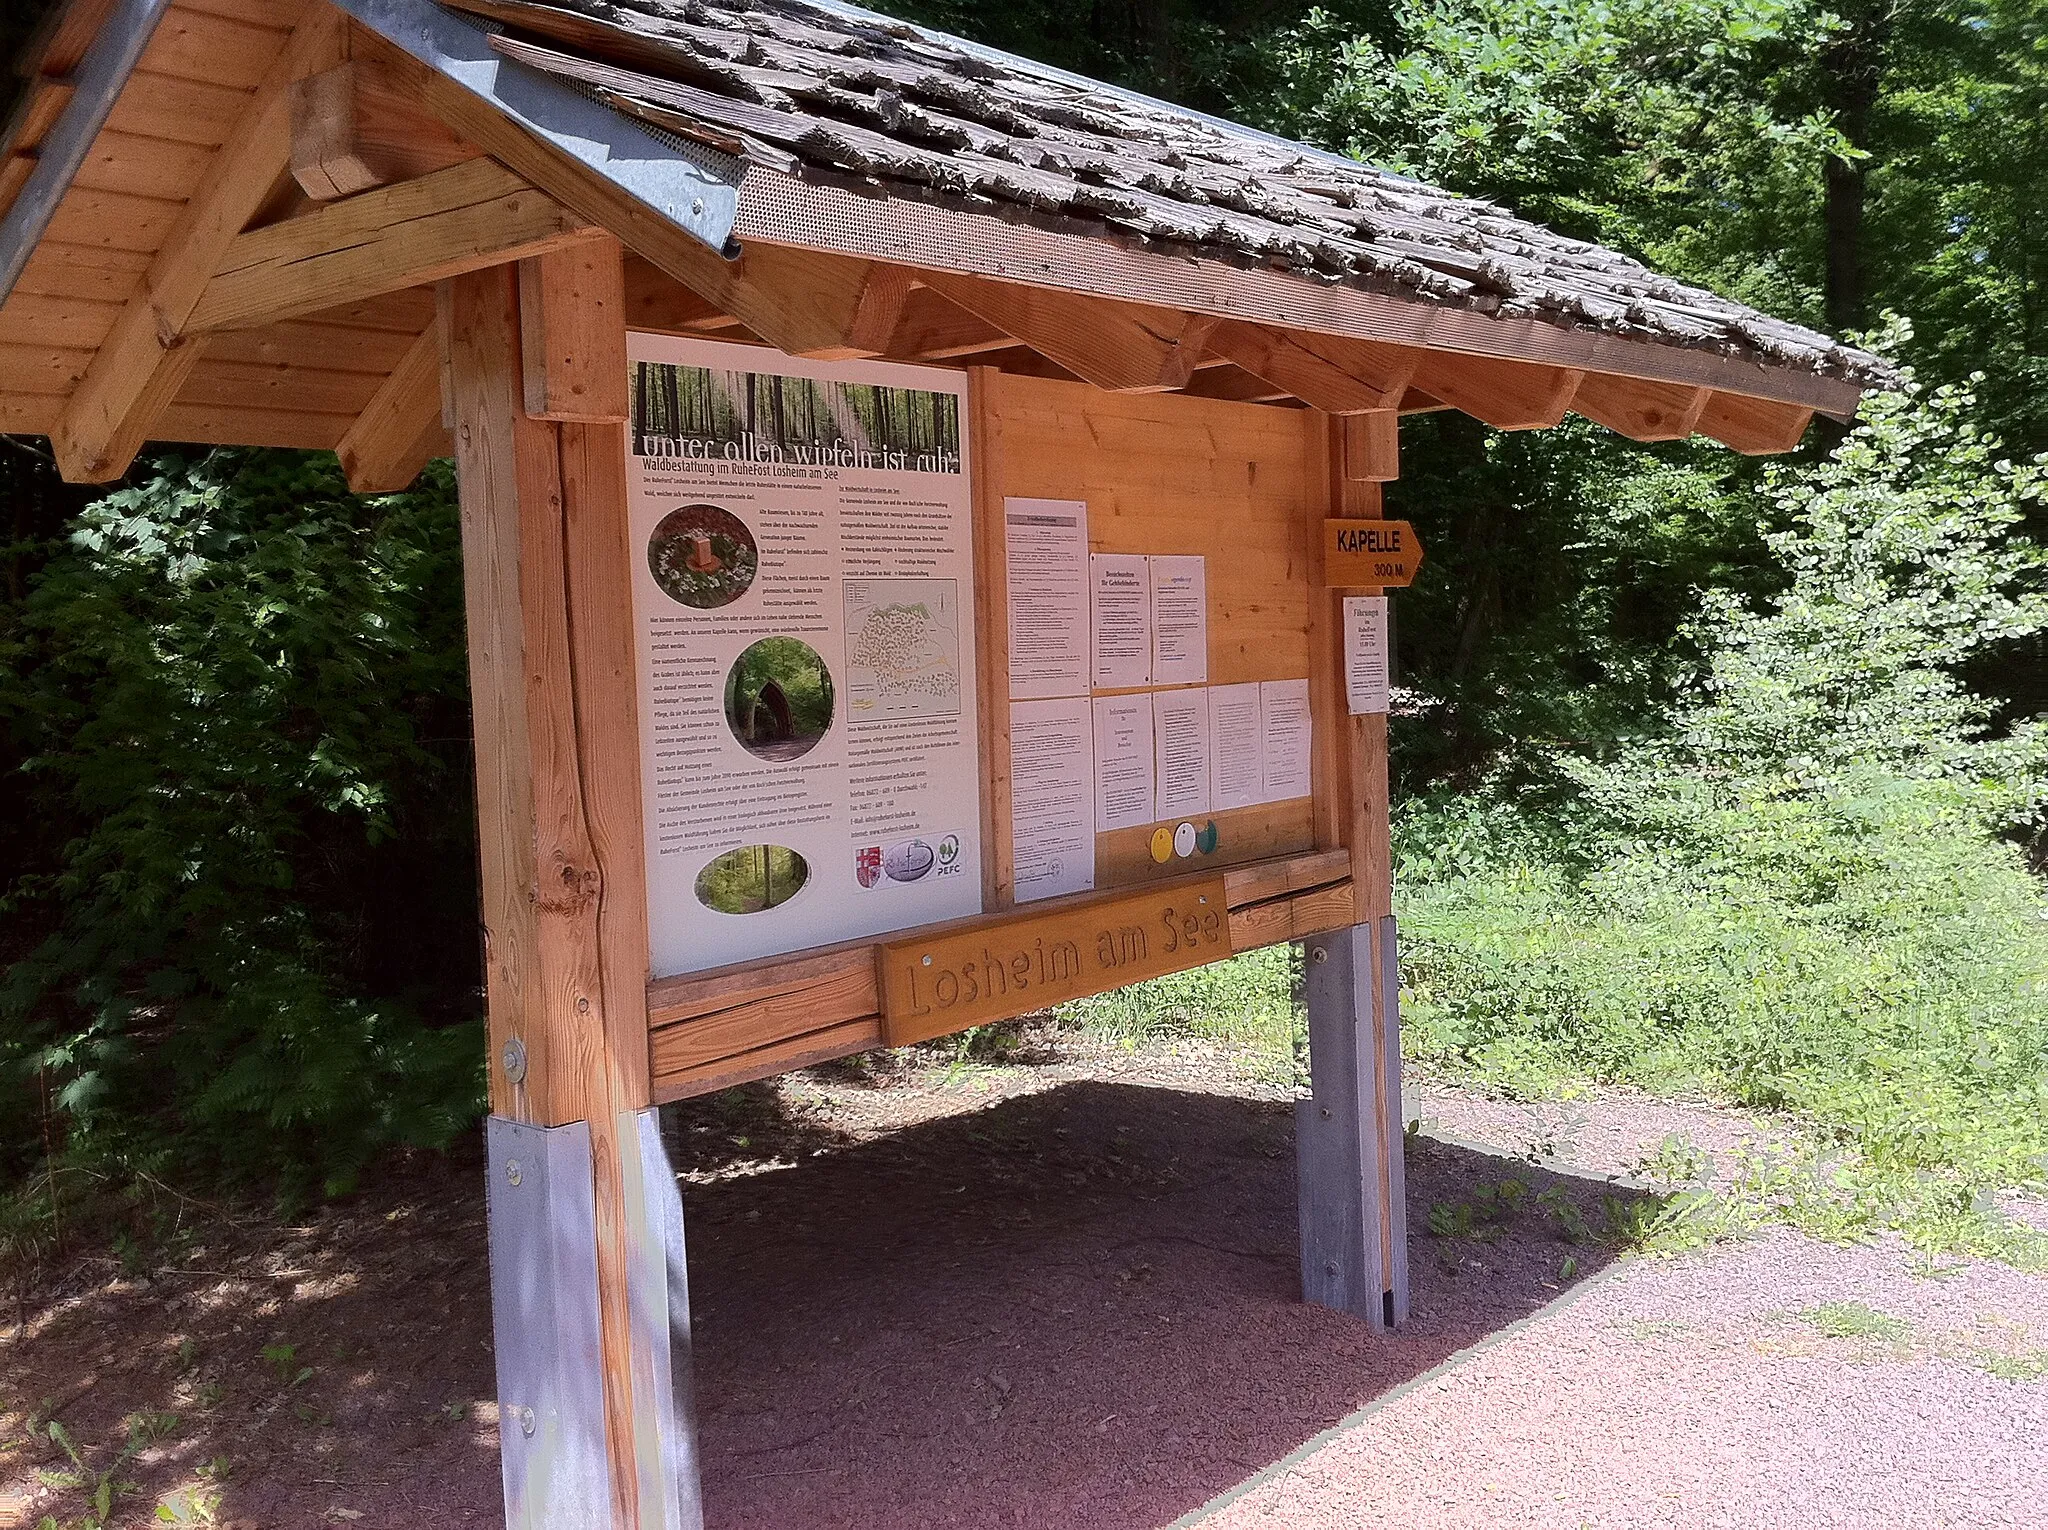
[1294,918,1409,1329]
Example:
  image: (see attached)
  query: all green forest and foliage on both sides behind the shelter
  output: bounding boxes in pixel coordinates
[0,0,2048,1251]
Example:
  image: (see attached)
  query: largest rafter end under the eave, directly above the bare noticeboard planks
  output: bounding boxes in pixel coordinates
[920,270,1217,393]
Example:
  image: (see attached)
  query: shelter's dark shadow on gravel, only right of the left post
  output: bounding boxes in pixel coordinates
[686,1083,1630,1530]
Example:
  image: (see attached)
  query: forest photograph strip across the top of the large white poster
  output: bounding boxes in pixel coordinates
[633,360,961,473]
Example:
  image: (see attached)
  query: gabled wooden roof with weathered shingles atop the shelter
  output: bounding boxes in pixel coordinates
[0,0,1884,487]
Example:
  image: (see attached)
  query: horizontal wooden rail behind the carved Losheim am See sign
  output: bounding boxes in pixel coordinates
[647,850,1356,1100]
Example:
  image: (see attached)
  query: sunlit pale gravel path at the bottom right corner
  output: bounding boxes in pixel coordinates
[1186,1231,2048,1530]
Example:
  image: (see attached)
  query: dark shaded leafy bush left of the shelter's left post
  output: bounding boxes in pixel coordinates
[0,453,483,1192]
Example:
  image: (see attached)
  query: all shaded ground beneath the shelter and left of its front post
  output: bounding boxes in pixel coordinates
[0,1083,1630,1530]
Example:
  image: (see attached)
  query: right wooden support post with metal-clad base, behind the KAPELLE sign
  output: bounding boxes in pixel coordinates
[1294,416,1407,1327]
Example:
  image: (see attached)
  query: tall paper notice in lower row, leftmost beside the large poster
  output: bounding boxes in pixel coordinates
[1010,696,1096,903]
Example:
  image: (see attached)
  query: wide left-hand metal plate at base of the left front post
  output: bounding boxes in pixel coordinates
[485,1116,612,1530]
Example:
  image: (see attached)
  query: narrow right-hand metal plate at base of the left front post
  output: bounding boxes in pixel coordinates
[618,1108,705,1530]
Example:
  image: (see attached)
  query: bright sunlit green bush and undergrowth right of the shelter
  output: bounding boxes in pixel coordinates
[1399,368,2048,1215]
